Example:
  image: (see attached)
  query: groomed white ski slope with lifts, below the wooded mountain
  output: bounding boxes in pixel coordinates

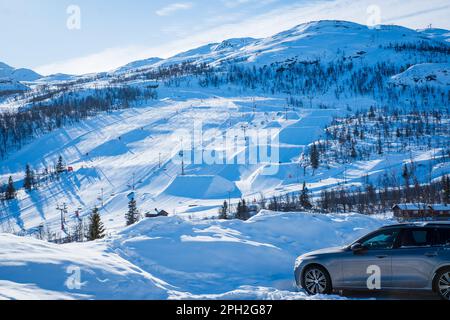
[0,81,448,233]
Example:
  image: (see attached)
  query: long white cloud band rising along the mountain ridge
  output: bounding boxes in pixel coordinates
[36,0,450,74]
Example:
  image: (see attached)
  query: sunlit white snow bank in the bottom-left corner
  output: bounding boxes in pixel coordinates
[0,234,169,300]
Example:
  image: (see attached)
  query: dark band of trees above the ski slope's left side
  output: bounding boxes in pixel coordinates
[0,87,157,159]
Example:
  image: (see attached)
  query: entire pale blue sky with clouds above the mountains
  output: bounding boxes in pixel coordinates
[0,0,450,74]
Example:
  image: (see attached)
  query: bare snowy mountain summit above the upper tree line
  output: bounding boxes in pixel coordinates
[115,20,449,73]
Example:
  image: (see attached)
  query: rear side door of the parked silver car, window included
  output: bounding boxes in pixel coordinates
[392,228,440,289]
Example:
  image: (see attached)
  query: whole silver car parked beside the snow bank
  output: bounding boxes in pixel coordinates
[295,222,450,300]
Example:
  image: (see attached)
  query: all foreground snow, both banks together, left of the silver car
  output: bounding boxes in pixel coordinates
[0,211,389,299]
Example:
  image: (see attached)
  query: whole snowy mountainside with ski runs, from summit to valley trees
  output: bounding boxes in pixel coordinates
[0,21,450,255]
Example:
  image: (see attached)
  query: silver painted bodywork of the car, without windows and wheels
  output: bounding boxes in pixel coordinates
[295,223,450,291]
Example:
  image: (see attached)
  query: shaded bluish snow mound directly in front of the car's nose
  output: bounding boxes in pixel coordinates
[113,211,385,299]
